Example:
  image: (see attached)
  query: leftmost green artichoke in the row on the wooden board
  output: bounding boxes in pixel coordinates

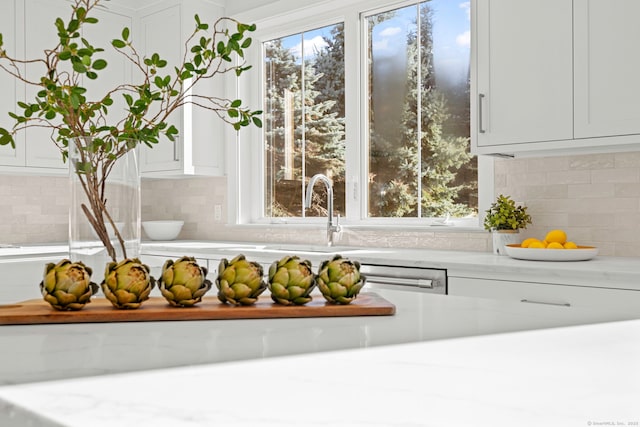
[40,259,98,310]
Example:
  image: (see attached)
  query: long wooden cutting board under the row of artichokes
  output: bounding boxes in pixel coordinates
[0,292,396,325]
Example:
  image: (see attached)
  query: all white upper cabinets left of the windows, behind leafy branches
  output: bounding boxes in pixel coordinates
[0,0,226,176]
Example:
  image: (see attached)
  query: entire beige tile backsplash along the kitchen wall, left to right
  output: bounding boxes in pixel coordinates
[0,152,640,257]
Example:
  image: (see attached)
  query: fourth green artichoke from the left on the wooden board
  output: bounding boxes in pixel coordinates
[216,255,267,305]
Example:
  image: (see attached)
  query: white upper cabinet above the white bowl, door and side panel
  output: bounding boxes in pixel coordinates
[139,0,225,176]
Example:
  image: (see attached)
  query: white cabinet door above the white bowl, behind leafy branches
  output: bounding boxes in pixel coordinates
[140,5,184,172]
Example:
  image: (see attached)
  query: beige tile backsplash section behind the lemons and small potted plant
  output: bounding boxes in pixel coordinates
[495,152,640,257]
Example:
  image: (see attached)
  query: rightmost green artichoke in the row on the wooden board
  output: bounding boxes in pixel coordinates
[318,255,366,304]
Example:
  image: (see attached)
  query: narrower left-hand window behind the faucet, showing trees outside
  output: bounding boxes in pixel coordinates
[264,24,345,217]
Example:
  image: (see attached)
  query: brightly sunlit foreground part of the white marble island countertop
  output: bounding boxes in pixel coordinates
[0,310,640,427]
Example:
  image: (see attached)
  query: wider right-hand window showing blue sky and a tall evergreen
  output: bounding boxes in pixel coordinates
[366,0,478,218]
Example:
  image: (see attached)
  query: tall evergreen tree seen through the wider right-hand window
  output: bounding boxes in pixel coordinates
[370,3,473,217]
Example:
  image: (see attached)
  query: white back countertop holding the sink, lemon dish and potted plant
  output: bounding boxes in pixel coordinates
[143,241,640,290]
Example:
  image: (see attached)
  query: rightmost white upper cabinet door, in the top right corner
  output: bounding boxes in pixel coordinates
[574,0,640,138]
